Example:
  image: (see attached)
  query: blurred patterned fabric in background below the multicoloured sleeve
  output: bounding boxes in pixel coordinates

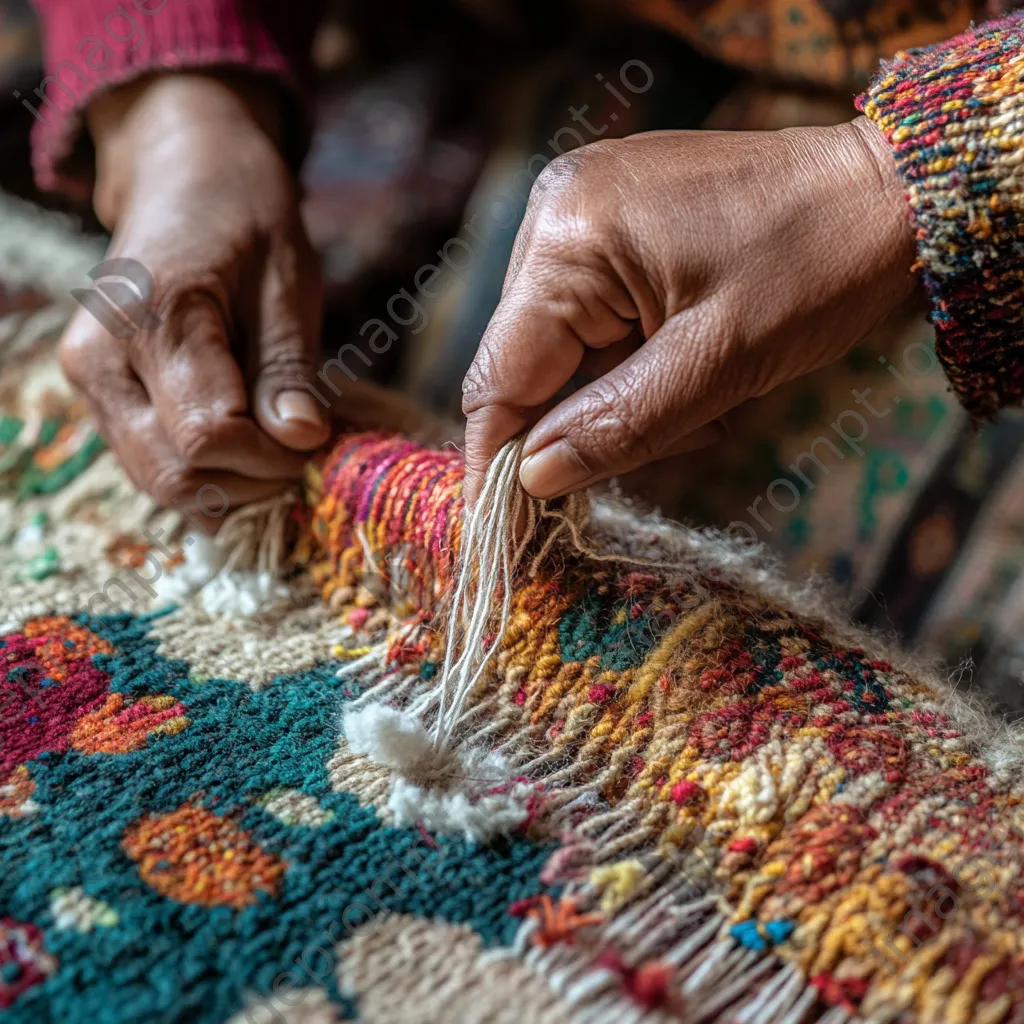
[657,311,1024,711]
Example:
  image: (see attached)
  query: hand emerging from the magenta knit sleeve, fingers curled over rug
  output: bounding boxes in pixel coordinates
[60,75,330,528]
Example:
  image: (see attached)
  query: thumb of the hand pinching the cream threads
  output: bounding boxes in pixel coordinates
[519,332,746,498]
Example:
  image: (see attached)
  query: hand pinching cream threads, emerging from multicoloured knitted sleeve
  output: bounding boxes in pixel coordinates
[463,118,914,501]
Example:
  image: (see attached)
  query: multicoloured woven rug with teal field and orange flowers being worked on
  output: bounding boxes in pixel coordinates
[6,195,1024,1024]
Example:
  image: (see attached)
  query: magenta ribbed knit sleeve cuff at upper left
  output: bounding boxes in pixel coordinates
[22,0,321,188]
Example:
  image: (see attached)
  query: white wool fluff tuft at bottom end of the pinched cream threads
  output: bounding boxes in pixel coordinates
[342,703,534,843]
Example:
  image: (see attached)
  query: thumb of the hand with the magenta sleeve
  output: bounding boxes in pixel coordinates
[253,243,331,452]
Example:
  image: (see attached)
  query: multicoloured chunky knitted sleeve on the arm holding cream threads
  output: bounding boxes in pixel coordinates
[857,12,1024,418]
